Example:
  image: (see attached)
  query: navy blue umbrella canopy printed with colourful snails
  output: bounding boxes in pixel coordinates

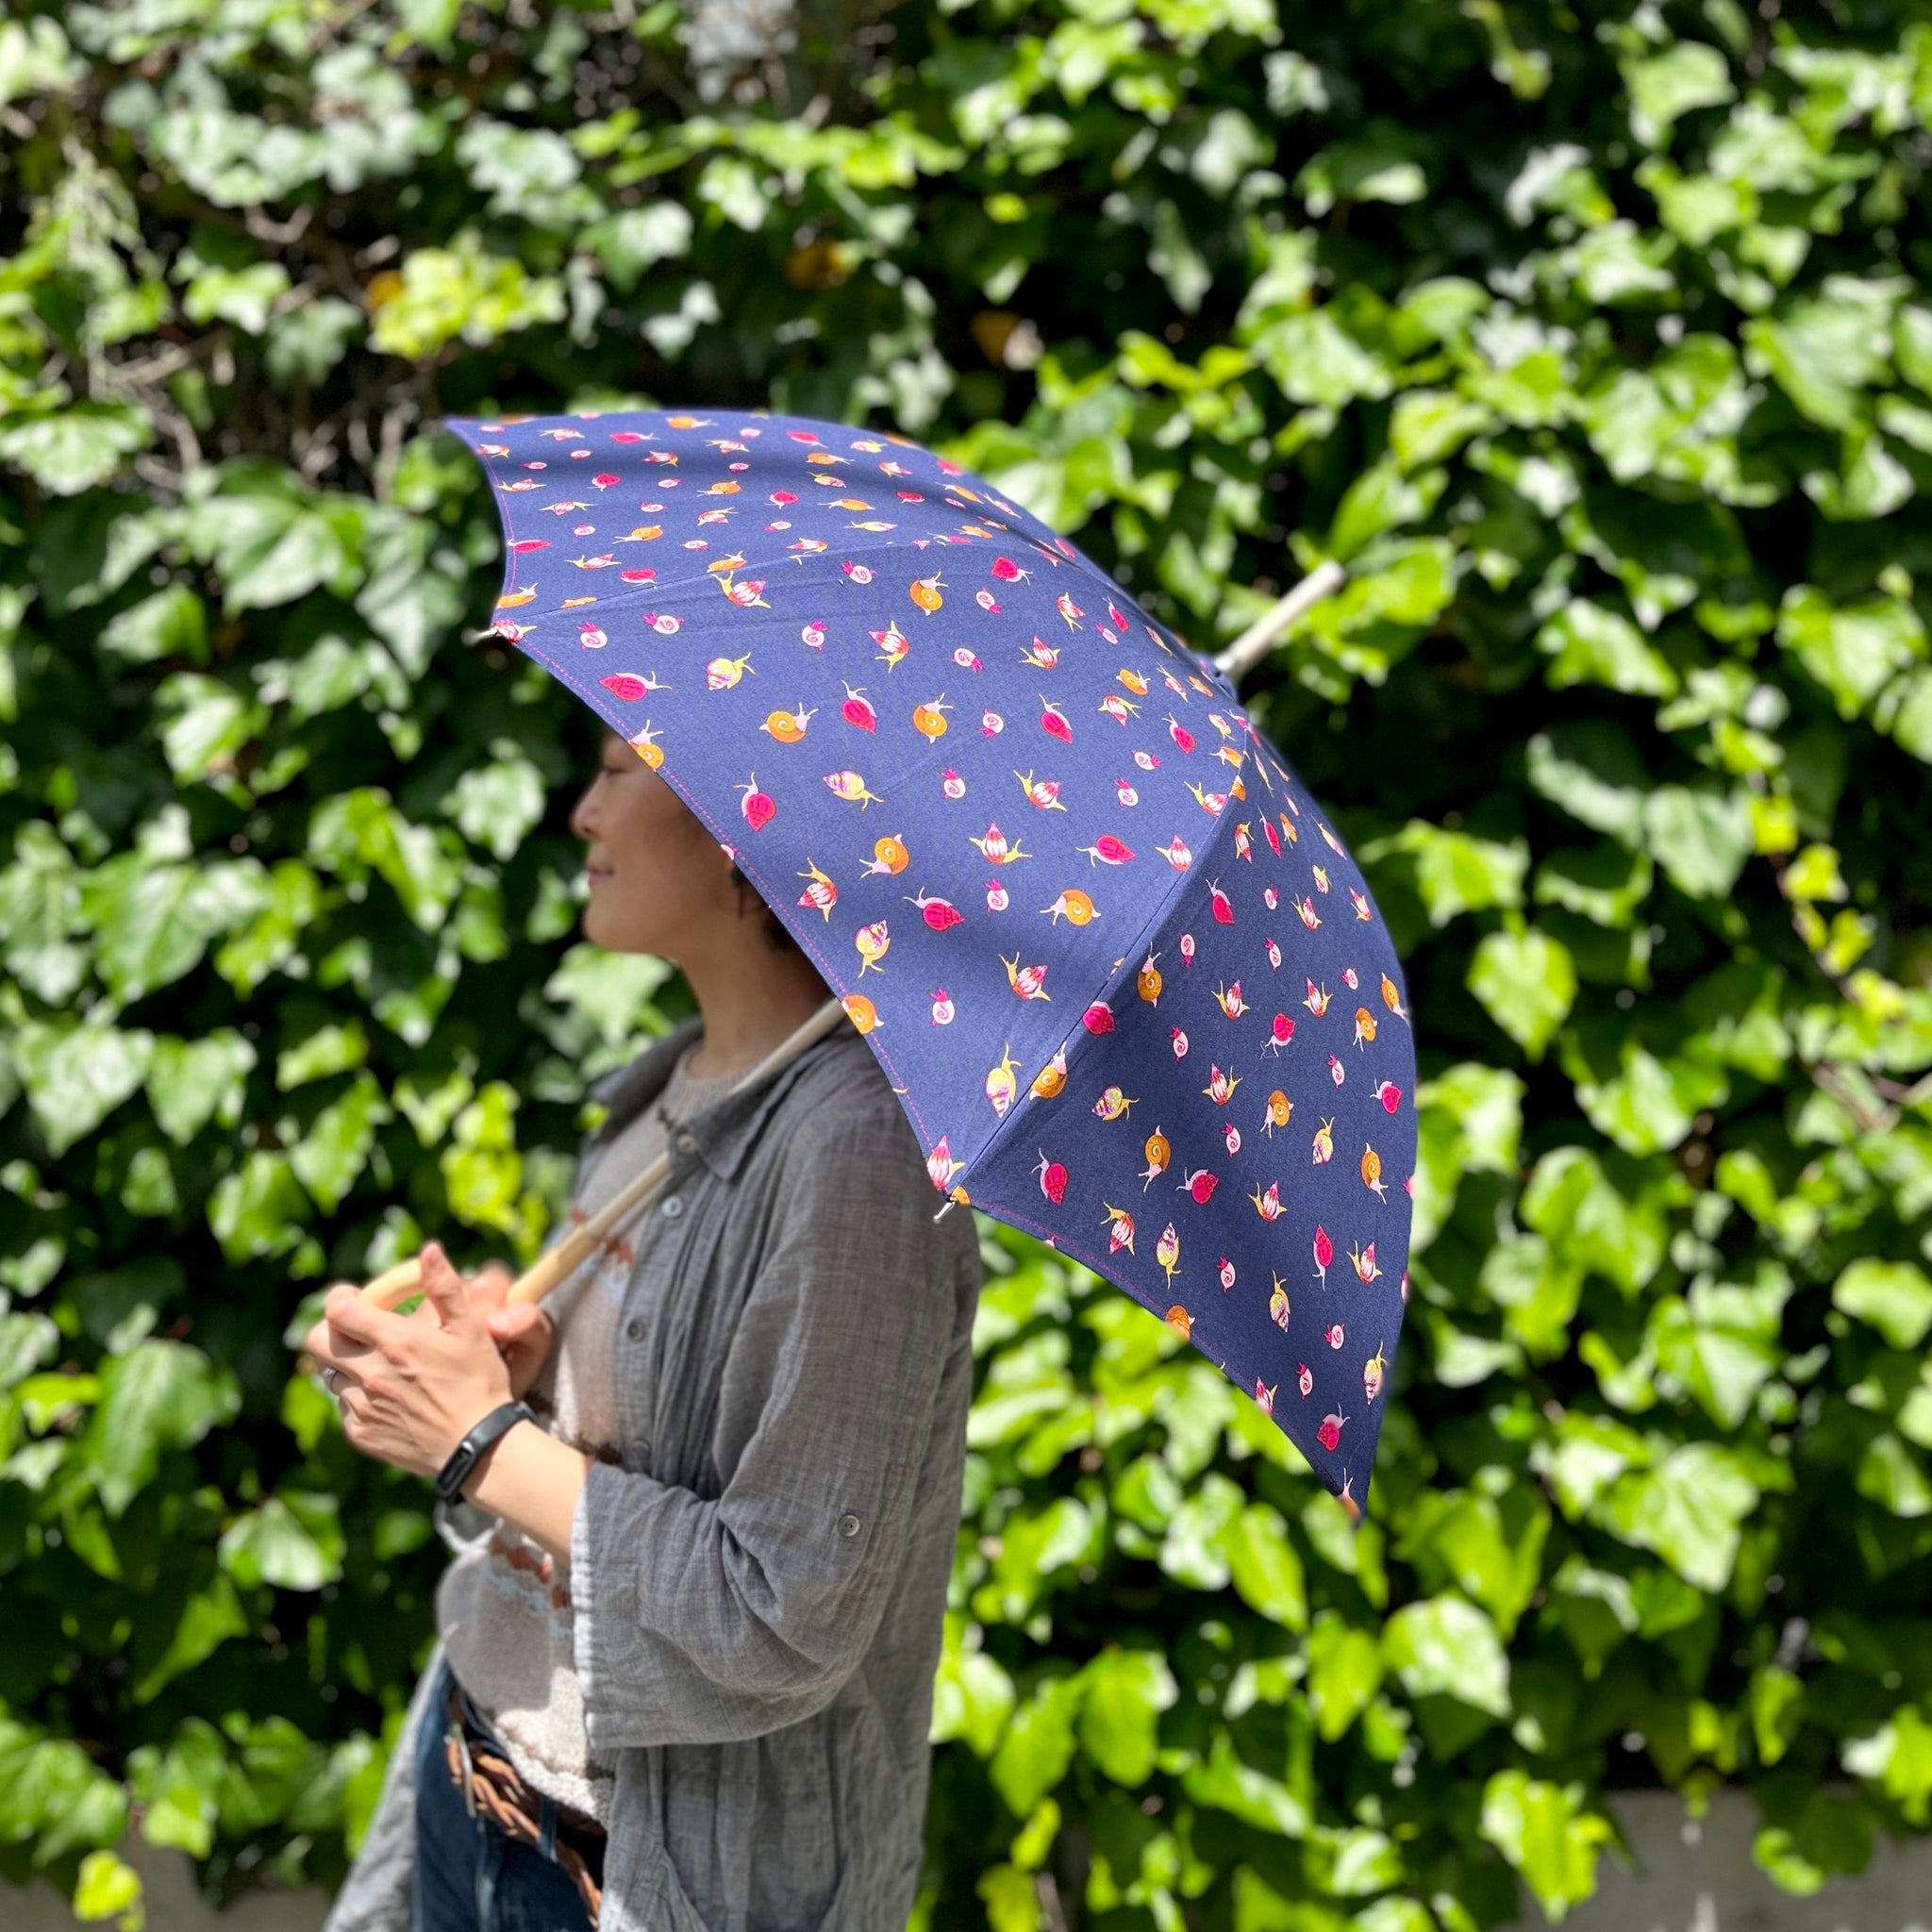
[392,409,1416,1505]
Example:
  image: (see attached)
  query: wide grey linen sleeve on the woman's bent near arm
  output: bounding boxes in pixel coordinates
[570,1095,968,1748]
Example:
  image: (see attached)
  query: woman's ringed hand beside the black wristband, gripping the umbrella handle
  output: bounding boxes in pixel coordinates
[304,1241,517,1476]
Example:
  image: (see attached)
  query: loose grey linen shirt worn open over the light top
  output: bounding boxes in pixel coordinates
[326,1020,981,1932]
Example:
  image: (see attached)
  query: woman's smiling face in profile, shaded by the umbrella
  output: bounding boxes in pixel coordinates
[570,732,738,964]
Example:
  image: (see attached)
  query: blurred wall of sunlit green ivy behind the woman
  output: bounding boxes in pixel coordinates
[0,0,1932,1932]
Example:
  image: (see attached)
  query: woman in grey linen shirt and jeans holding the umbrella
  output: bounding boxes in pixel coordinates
[306,734,979,1932]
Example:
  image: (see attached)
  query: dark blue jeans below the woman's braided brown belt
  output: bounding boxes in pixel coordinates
[413,1663,590,1932]
